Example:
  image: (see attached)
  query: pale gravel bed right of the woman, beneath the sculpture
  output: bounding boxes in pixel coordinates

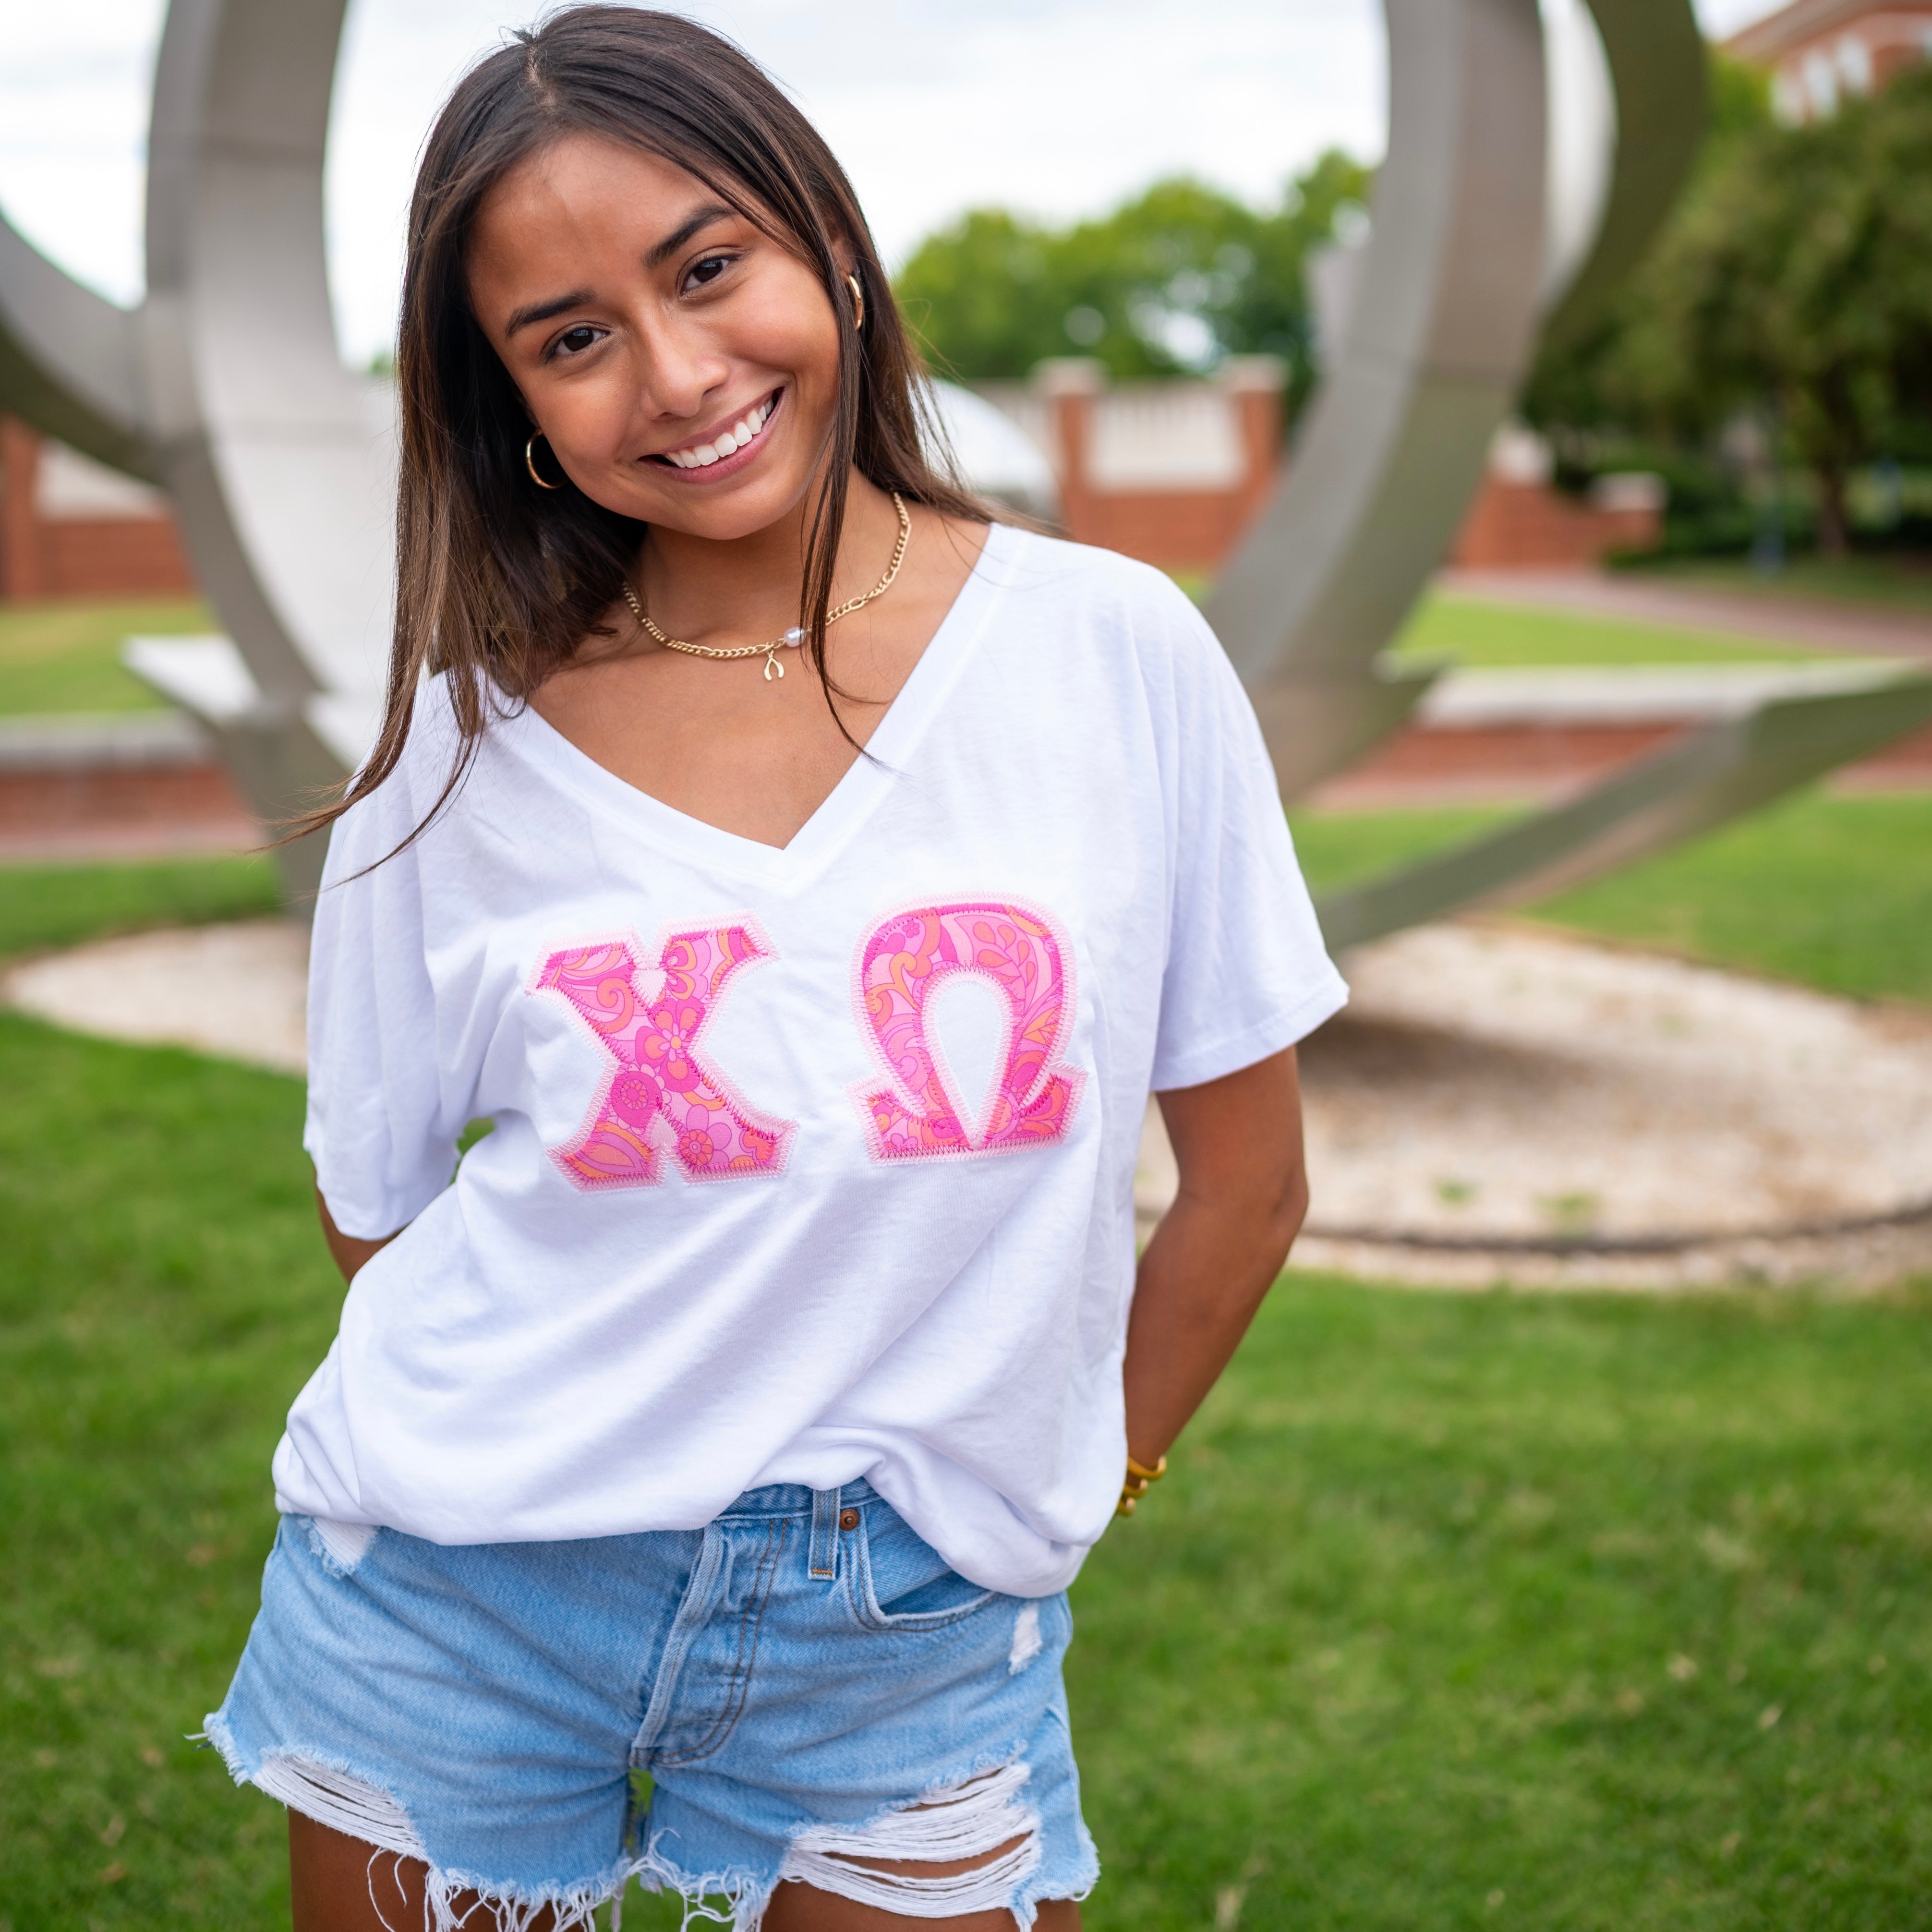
[1136,921,1932,1287]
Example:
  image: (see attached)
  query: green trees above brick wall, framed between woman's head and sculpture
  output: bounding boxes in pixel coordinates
[894,153,1370,415]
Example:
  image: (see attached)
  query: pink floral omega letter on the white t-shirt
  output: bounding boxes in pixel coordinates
[852,900,1086,1161]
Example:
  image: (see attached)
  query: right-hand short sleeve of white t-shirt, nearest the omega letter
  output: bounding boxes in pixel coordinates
[1151,611,1349,1092]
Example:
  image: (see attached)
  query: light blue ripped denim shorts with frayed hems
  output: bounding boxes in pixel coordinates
[207,1482,1099,1932]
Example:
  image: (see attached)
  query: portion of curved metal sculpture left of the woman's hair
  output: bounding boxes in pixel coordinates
[0,0,373,896]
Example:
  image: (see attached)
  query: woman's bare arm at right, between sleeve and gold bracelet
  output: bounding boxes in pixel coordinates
[1124,1047,1308,1468]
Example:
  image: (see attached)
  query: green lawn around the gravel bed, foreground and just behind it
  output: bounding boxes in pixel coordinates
[0,823,1932,1932]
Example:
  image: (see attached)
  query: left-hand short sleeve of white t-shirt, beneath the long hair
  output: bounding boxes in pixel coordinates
[302,769,468,1240]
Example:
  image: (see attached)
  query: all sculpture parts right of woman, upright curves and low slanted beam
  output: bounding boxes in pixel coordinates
[1208,0,1932,947]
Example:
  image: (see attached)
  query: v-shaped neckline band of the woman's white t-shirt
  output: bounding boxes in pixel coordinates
[493,524,1024,885]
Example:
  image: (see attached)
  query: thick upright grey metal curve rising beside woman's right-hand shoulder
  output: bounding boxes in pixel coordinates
[1208,0,1547,798]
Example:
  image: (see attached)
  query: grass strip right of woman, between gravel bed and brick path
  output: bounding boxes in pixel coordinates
[1294,790,1932,1002]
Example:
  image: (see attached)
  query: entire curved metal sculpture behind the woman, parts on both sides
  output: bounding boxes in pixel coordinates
[0,0,1932,927]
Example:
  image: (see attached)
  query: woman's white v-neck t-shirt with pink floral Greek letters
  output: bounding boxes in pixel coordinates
[274,528,1347,1596]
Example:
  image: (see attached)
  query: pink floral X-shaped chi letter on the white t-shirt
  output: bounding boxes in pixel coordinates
[526,921,798,1188]
